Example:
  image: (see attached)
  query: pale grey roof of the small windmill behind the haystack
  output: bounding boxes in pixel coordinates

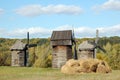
[78,41,96,50]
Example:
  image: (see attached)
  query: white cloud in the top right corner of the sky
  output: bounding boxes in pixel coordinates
[93,0,120,11]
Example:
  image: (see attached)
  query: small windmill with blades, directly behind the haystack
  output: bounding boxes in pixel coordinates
[78,30,106,59]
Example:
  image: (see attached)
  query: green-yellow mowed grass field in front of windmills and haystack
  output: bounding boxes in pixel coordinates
[0,66,120,80]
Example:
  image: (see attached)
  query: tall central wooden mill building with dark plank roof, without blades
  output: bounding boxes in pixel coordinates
[51,30,73,68]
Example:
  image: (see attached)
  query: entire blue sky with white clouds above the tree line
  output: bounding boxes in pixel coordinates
[0,0,120,38]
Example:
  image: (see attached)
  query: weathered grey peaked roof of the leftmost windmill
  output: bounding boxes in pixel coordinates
[10,40,26,50]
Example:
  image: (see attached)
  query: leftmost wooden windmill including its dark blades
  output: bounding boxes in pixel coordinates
[10,32,37,66]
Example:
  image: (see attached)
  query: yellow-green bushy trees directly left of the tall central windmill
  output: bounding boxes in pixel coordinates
[33,40,52,67]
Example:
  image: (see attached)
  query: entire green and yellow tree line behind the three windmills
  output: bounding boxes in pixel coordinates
[0,36,120,69]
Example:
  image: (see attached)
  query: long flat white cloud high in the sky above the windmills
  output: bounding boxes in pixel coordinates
[15,5,83,17]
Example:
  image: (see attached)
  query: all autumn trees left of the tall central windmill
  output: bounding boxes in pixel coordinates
[0,38,52,67]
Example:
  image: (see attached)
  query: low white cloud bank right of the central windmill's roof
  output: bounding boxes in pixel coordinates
[75,24,120,37]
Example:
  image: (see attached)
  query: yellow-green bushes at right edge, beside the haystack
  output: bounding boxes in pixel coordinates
[97,42,120,69]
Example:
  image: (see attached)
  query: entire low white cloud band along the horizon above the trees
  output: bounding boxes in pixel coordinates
[0,24,120,38]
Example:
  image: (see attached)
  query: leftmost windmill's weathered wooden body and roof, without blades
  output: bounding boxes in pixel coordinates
[10,40,27,66]
